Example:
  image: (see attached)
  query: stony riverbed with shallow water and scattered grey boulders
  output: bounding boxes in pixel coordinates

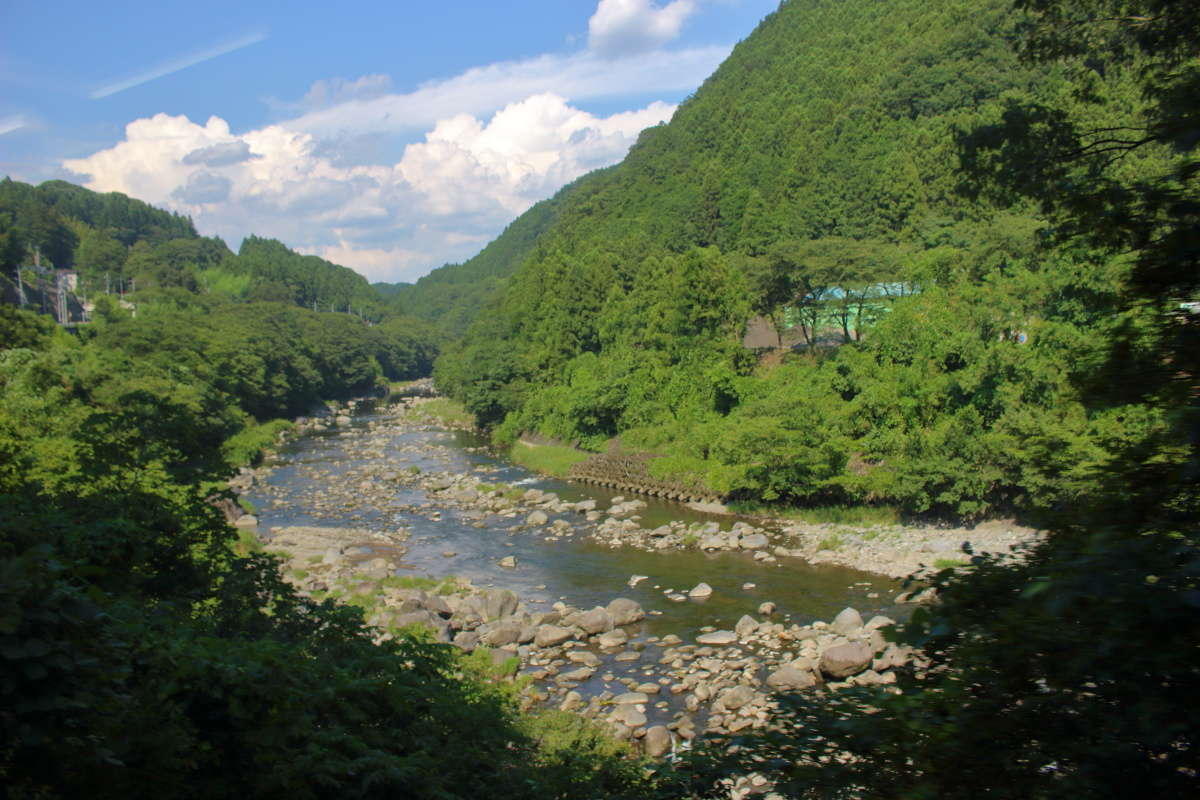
[225,399,1032,756]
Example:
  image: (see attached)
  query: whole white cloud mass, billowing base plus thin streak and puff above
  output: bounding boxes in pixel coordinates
[62,0,731,281]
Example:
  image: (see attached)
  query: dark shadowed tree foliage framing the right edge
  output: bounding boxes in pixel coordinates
[657,0,1200,800]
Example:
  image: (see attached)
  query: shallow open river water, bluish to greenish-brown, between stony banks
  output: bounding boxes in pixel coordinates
[246,415,902,640]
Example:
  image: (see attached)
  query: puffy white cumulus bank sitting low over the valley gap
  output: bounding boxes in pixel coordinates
[64,92,674,281]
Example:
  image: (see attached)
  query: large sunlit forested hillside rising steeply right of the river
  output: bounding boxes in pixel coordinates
[438,0,1165,517]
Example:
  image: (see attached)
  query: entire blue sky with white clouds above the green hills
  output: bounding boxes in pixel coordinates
[0,0,778,281]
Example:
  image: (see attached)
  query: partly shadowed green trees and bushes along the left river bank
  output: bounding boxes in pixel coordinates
[0,313,642,798]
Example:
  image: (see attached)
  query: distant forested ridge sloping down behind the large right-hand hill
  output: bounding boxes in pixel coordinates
[373,178,580,339]
